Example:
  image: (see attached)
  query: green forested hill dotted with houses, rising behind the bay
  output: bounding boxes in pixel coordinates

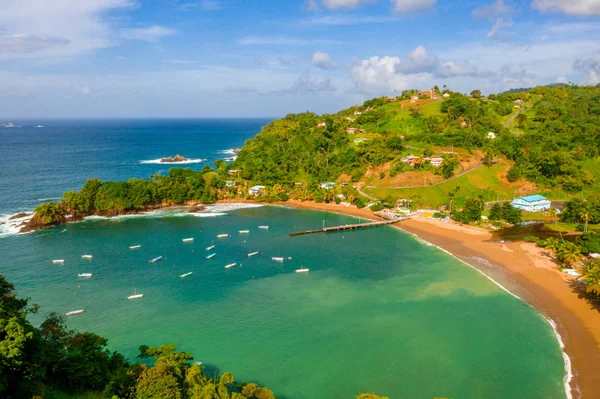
[231,86,600,193]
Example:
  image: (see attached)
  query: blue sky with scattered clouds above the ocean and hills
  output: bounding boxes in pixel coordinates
[0,0,600,117]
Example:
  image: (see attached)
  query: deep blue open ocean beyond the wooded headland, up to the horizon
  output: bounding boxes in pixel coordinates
[0,119,269,215]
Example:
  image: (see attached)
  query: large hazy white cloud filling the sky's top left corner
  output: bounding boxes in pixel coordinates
[0,0,133,59]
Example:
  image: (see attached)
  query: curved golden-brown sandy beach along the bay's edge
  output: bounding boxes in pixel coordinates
[273,201,600,398]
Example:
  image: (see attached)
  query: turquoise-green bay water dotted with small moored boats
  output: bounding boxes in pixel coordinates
[0,206,565,399]
